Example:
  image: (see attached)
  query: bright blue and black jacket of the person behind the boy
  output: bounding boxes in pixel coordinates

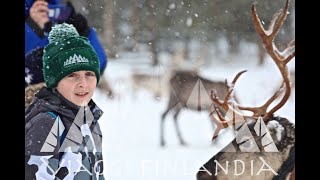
[24,0,108,86]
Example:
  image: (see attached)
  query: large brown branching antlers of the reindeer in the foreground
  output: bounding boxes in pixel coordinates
[211,0,295,140]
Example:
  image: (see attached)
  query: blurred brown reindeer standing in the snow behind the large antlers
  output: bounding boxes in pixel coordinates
[160,70,240,146]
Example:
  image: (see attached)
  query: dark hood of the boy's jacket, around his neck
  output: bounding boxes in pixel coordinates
[25,87,103,122]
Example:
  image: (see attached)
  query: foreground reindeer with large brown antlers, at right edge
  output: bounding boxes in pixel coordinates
[197,0,295,180]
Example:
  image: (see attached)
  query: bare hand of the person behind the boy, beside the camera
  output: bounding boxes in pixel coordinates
[30,0,49,29]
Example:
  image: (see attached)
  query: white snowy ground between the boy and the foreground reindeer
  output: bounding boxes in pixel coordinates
[93,46,295,180]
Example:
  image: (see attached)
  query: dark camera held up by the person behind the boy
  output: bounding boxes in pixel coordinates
[48,4,72,21]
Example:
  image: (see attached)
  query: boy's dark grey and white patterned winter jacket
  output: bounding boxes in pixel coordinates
[25,87,104,180]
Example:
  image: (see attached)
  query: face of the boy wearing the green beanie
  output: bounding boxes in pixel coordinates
[57,71,97,106]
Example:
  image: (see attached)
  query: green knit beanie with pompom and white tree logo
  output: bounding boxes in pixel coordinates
[42,23,100,89]
